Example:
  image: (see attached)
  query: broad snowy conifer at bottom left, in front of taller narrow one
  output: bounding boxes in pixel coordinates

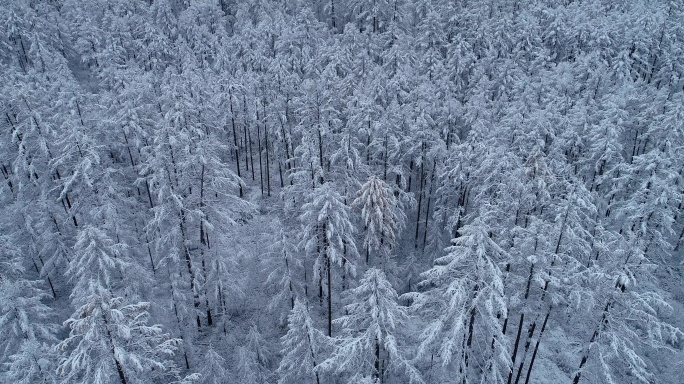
[57,288,180,384]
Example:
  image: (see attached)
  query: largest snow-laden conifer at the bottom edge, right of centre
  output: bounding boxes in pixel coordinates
[405,218,510,383]
